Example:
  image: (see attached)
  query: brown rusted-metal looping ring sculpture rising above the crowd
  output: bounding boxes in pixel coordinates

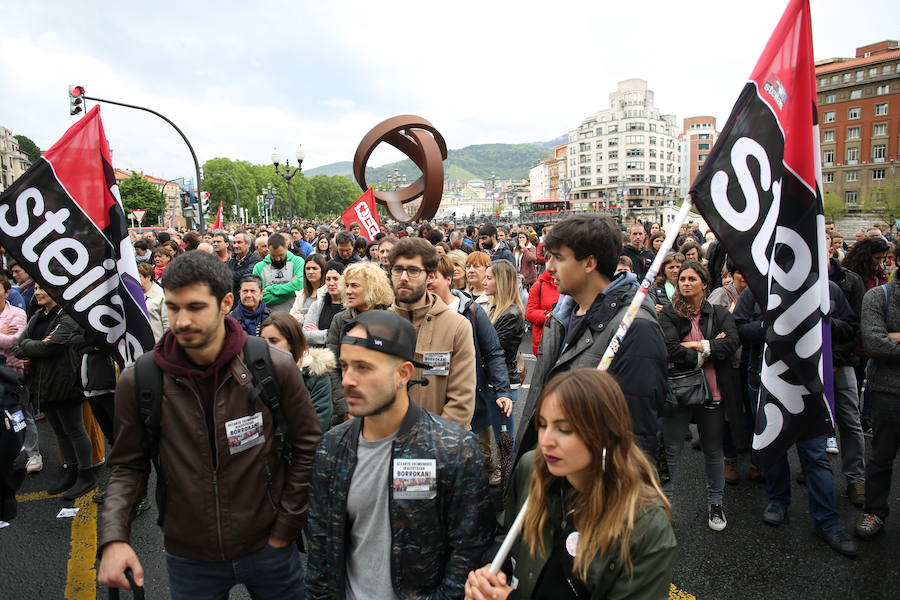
[353,115,447,223]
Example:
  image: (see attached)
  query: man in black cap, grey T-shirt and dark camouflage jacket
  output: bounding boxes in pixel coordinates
[306,310,493,600]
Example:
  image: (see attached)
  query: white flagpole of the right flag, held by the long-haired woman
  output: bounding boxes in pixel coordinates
[490,195,692,575]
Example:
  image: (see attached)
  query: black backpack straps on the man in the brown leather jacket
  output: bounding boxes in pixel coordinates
[134,336,291,522]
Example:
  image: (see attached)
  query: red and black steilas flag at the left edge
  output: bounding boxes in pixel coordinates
[0,106,153,365]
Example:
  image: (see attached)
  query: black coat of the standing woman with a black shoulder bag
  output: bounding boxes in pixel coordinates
[659,300,750,451]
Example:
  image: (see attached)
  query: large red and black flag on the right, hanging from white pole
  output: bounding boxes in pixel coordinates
[691,0,832,469]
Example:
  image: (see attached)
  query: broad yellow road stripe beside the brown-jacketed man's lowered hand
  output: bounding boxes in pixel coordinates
[65,493,97,600]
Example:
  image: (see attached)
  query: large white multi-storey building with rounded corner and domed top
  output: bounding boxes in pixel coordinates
[562,79,684,219]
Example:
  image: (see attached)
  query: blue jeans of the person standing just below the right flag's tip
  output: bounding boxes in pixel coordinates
[766,435,841,532]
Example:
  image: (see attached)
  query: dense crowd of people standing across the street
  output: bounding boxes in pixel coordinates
[0,215,900,600]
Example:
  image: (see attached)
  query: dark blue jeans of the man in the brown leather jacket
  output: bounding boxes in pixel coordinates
[166,542,306,600]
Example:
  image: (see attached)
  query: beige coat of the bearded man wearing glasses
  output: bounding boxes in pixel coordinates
[391,292,475,429]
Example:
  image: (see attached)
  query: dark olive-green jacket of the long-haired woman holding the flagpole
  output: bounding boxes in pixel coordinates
[497,451,677,600]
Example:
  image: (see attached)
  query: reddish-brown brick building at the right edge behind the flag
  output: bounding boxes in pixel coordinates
[816,40,900,210]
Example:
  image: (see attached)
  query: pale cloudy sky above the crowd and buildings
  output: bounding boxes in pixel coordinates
[0,0,900,179]
